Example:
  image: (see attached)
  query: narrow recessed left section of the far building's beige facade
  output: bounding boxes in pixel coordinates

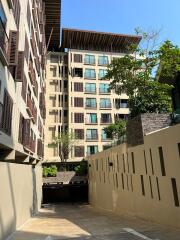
[45,52,69,162]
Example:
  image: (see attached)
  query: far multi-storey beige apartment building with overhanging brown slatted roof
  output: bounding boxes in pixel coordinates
[45,29,141,161]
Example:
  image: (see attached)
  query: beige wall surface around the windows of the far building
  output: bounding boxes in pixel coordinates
[45,49,129,161]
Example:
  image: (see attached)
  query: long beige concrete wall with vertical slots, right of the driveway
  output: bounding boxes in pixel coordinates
[88,124,180,227]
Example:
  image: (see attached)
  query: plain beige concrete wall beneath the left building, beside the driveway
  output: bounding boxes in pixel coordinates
[0,162,42,240]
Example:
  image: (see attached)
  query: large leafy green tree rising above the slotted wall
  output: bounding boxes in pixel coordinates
[105,29,172,117]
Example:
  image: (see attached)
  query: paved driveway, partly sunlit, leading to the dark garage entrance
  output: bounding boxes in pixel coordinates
[10,205,180,240]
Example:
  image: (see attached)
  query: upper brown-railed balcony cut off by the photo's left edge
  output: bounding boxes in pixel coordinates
[0,21,9,66]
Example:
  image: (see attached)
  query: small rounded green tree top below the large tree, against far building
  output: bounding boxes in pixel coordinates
[104,120,126,140]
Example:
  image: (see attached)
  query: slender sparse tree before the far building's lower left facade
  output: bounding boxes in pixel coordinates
[50,131,77,162]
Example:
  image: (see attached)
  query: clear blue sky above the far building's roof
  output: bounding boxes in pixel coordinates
[61,0,180,46]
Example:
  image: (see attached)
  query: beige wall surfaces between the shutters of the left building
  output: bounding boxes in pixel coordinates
[0,0,45,163]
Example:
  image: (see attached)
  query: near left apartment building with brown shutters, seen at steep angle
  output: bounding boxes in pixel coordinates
[0,0,46,164]
